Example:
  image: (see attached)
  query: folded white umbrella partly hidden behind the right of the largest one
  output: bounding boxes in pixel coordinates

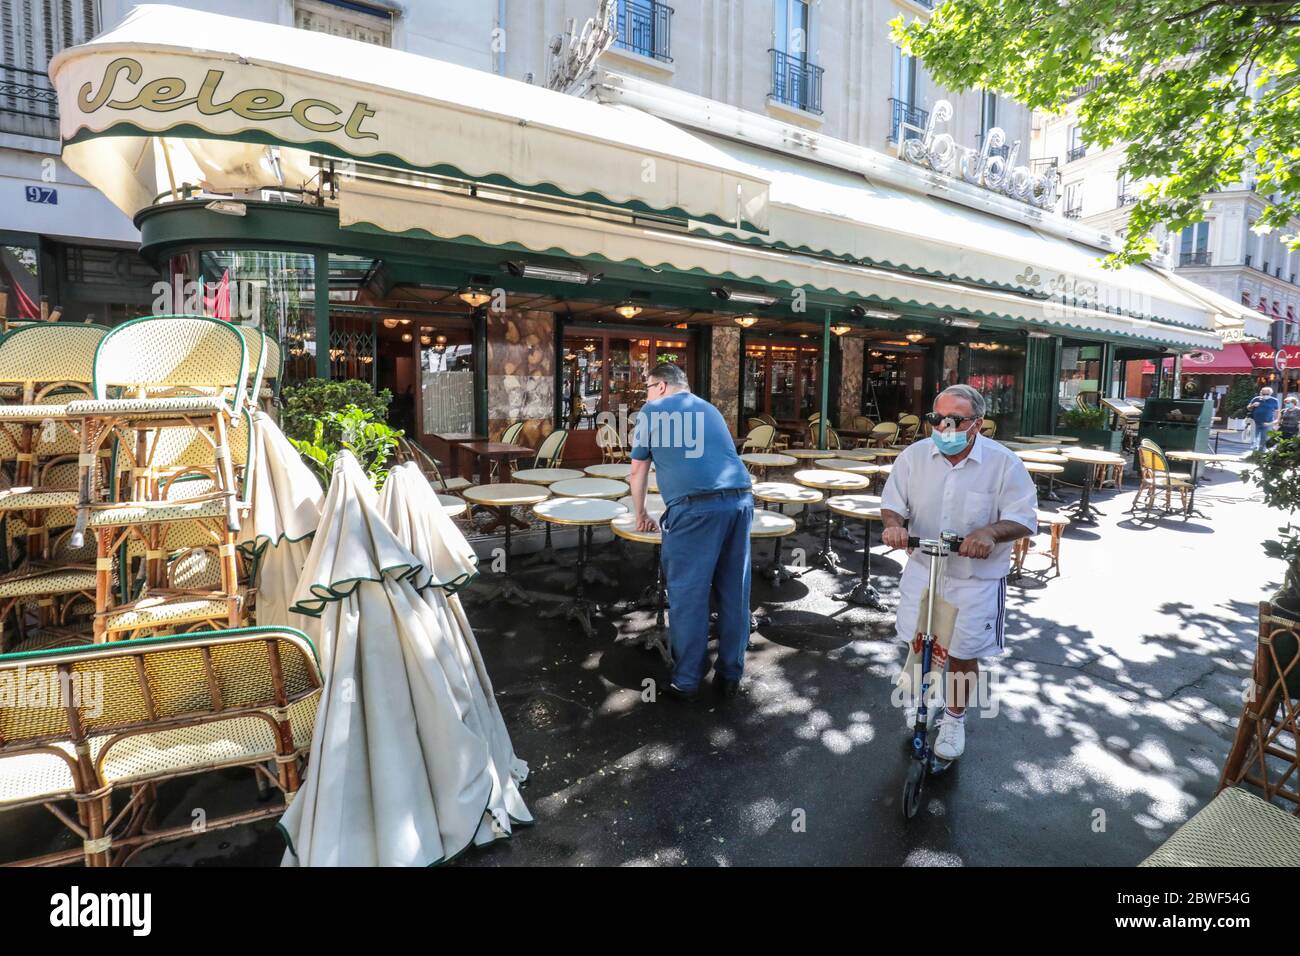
[380,462,533,843]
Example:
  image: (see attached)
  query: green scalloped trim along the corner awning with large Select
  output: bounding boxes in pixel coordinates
[64,120,763,233]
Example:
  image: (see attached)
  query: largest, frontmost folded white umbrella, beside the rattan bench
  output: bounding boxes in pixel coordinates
[281,451,493,866]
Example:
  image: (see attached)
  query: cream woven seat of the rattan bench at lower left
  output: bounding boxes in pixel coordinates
[0,697,319,808]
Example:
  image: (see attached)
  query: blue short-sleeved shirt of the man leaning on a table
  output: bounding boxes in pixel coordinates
[632,392,750,505]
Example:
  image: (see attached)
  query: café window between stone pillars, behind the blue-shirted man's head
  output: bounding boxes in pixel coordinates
[560,329,694,431]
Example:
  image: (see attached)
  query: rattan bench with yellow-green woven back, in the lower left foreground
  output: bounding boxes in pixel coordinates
[0,627,321,866]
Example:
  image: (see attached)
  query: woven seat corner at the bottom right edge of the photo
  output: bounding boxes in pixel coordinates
[1139,787,1300,868]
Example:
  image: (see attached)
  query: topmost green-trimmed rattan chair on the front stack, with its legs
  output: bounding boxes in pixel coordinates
[68,316,253,544]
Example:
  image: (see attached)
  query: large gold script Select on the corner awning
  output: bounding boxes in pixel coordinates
[77,56,380,139]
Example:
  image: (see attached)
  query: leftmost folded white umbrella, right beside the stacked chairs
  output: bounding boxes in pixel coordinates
[239,411,325,637]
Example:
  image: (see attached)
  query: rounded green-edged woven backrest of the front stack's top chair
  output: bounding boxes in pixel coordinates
[94,316,251,410]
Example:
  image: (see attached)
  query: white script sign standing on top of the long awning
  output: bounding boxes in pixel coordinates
[898,100,1061,209]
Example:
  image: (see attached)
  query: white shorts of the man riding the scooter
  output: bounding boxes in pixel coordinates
[894,559,1006,661]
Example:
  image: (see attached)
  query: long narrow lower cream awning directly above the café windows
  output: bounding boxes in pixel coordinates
[339,179,1221,349]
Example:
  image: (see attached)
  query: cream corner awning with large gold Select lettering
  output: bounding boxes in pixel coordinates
[49,5,767,232]
